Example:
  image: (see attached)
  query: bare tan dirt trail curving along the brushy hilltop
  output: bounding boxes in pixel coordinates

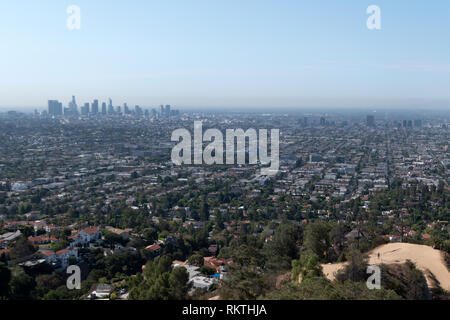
[322,243,450,291]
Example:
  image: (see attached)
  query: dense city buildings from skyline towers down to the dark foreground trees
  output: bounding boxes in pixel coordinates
[0,106,450,299]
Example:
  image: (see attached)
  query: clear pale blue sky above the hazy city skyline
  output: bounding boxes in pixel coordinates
[0,0,450,108]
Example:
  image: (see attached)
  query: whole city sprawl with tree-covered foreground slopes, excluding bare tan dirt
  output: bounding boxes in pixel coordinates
[0,97,450,299]
